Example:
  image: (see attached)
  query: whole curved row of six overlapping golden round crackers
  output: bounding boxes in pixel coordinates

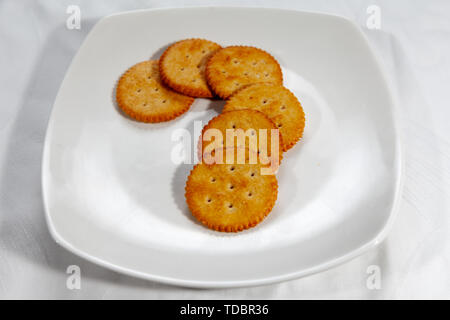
[116,39,305,232]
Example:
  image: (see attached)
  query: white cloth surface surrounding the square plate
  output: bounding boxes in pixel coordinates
[0,0,450,299]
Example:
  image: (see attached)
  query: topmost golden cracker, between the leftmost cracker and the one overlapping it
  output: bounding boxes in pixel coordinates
[159,39,221,98]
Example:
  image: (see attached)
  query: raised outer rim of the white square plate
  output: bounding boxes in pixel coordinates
[41,6,404,288]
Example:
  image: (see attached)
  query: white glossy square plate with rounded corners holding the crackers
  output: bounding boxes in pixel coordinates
[42,8,401,287]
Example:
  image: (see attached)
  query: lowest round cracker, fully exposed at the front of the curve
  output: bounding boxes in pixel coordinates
[185,158,278,232]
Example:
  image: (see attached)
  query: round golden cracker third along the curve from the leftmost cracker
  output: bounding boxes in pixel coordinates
[206,46,283,99]
